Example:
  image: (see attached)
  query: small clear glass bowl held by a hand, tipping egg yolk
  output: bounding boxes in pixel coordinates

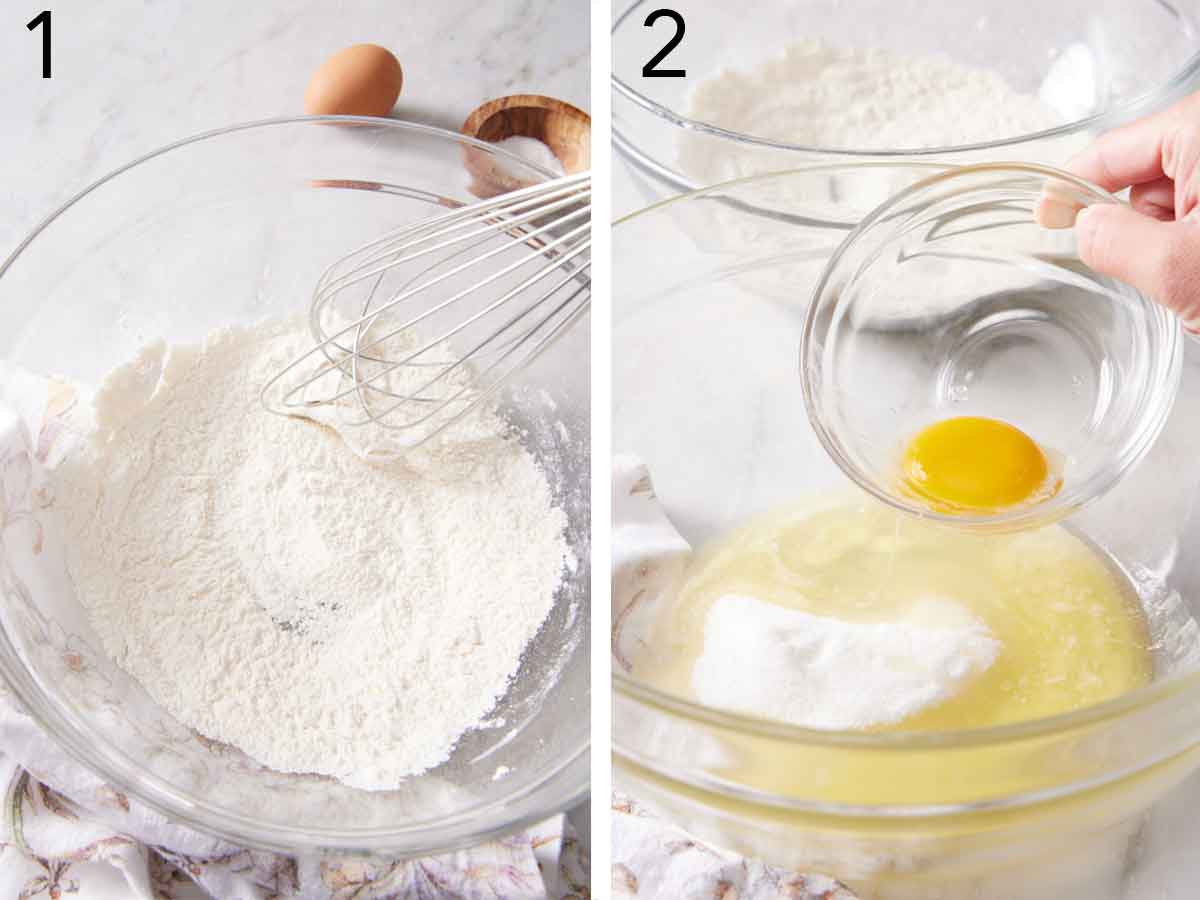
[800,163,1183,530]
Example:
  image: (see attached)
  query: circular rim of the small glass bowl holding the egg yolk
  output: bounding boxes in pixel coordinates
[799,162,1183,532]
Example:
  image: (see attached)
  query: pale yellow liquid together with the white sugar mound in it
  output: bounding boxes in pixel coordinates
[637,502,1152,744]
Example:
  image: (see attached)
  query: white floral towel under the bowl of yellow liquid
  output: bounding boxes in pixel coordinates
[612,794,858,900]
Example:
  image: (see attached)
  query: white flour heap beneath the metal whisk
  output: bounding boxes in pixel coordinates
[55,322,566,788]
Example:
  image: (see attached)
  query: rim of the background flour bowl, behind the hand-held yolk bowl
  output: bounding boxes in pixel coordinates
[610,0,1200,157]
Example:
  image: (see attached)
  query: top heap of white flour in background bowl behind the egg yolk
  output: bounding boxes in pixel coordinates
[680,40,1061,184]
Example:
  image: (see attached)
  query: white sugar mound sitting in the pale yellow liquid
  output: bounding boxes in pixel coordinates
[692,594,1000,730]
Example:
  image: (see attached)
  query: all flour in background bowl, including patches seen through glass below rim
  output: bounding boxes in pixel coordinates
[679,40,1087,325]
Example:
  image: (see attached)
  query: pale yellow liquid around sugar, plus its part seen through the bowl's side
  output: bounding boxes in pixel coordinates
[635,498,1153,811]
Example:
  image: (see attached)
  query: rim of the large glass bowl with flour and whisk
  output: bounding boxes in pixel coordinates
[0,115,592,858]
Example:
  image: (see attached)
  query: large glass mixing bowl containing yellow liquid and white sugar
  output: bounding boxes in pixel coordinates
[612,163,1200,900]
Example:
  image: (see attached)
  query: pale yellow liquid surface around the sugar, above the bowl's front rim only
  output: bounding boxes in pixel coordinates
[636,500,1152,731]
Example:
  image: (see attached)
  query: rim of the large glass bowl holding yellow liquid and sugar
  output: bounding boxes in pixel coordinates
[611,160,1200,768]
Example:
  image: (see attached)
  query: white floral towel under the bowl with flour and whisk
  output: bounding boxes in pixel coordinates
[0,690,590,900]
